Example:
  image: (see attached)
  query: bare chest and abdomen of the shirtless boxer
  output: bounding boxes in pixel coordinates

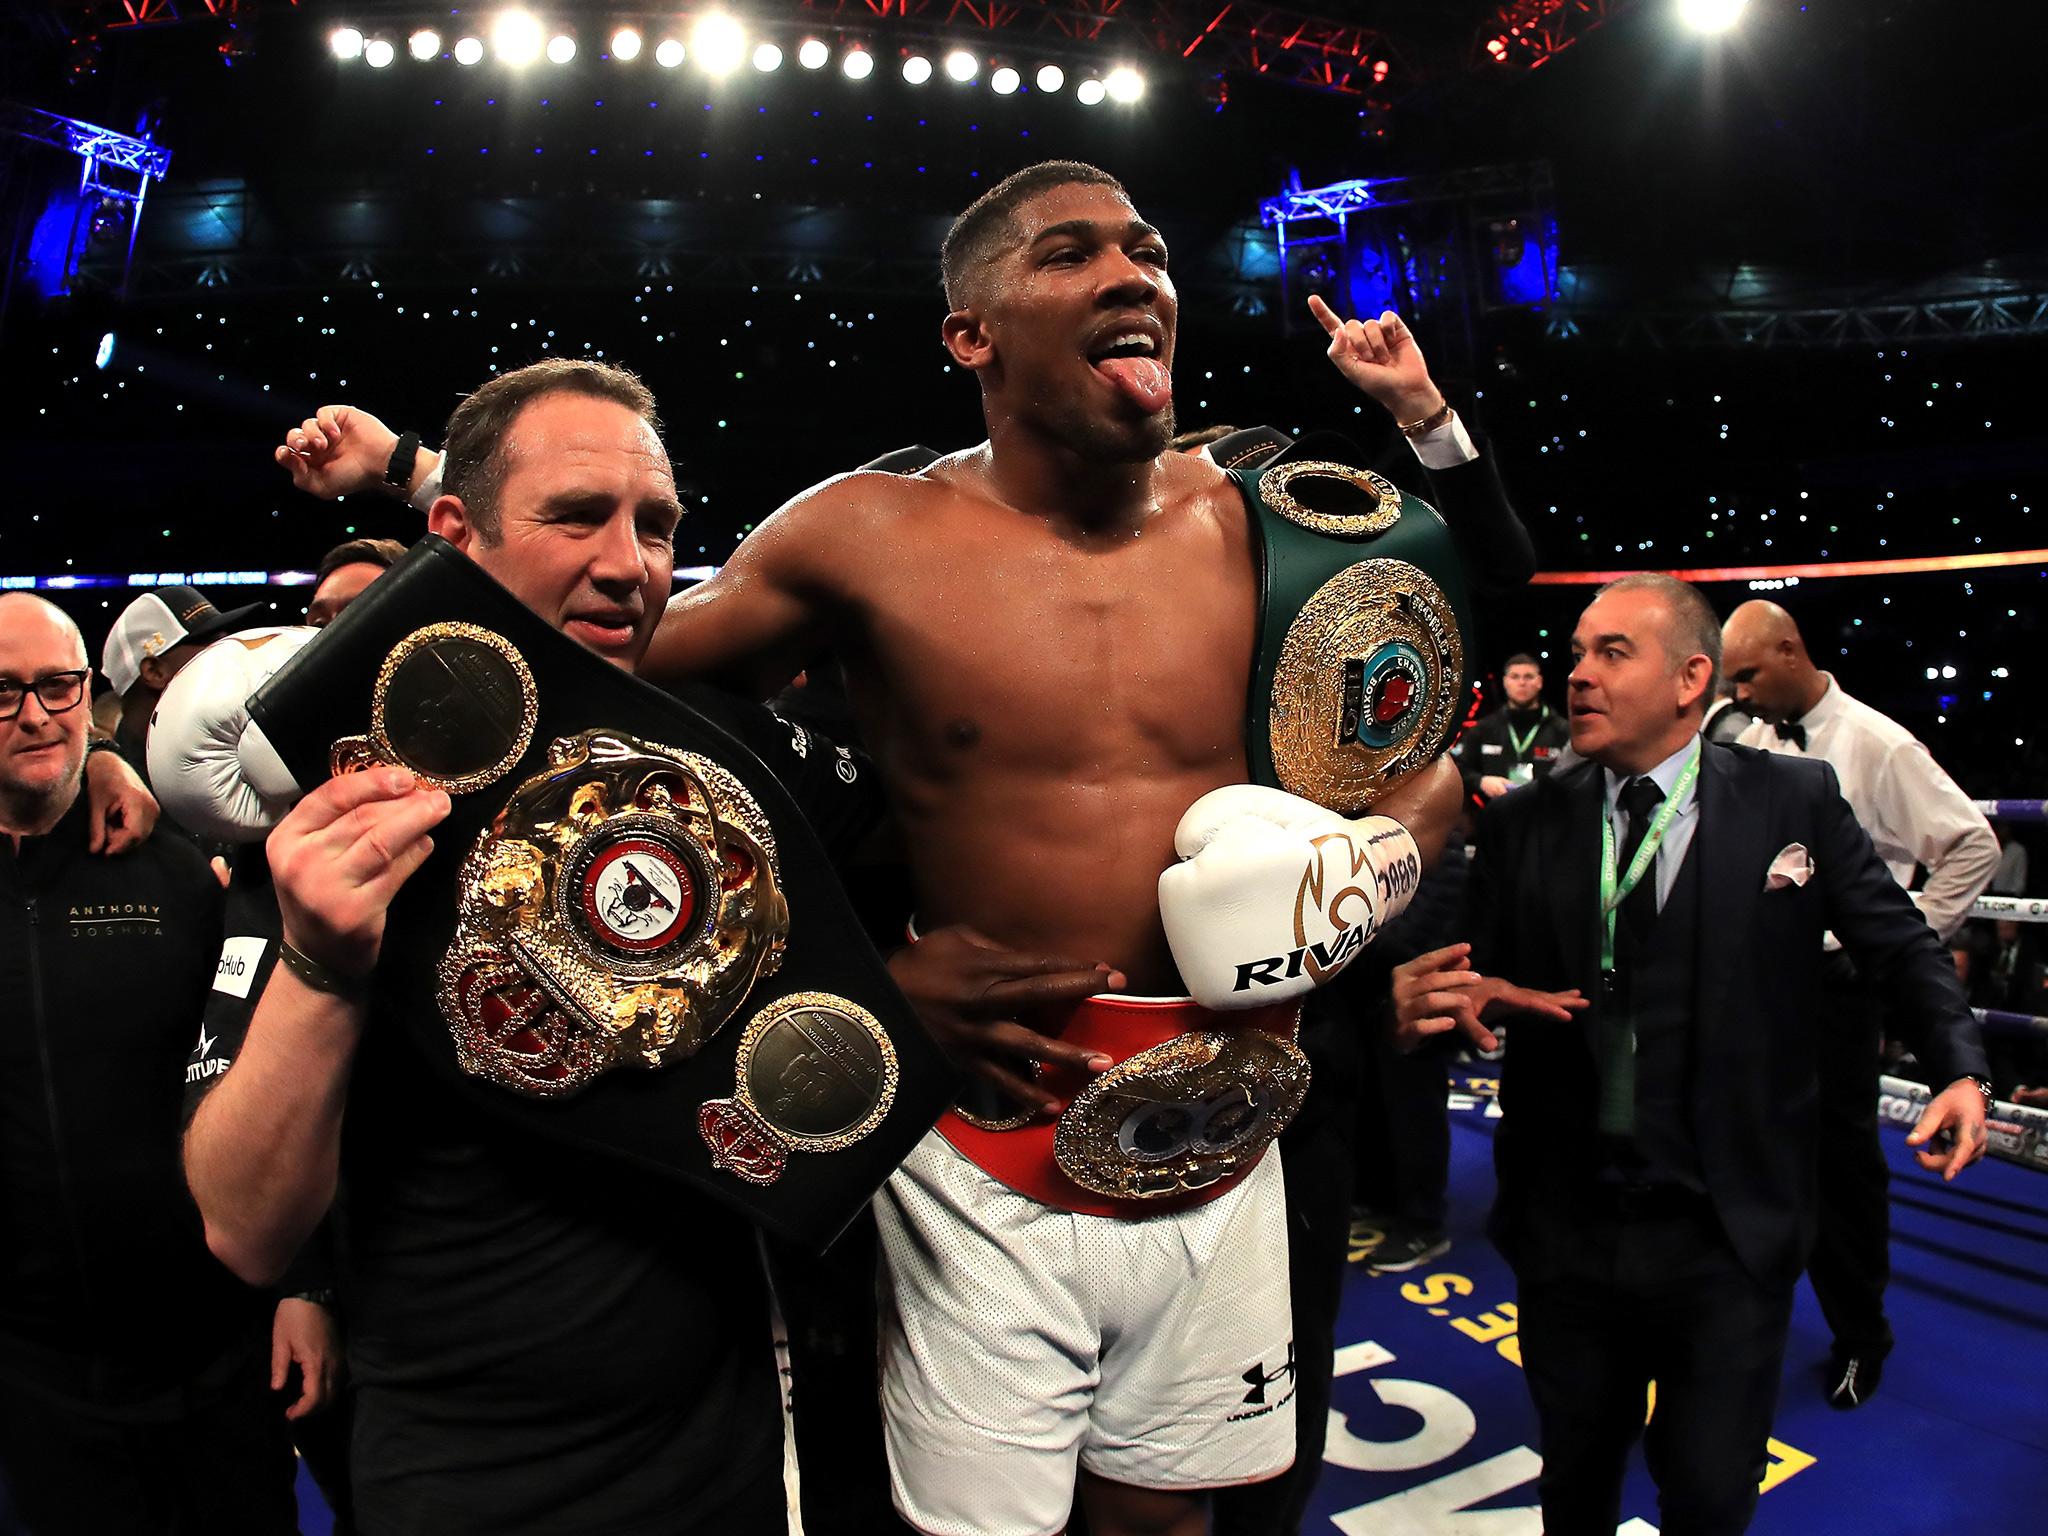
[846,475,1255,991]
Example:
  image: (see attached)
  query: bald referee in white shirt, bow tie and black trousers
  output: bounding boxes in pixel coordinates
[1720,600,1999,1409]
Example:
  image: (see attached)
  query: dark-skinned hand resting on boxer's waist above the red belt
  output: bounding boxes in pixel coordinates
[889,928,1128,1114]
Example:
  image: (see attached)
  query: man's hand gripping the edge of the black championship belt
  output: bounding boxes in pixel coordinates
[268,768,449,977]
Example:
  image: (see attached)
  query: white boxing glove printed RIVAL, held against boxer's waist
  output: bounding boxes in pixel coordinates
[1159,784,1421,1010]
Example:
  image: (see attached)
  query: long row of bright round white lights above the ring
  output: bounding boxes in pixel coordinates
[328,10,1145,106]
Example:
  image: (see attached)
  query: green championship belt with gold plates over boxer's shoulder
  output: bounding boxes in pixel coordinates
[1219,454,1473,815]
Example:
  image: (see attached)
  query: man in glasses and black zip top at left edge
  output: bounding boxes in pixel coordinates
[0,592,297,1536]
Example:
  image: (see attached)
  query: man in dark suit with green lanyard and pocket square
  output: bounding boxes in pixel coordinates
[1395,575,1989,1536]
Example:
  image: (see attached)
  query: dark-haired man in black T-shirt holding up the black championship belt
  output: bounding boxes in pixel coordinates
[186,360,913,1536]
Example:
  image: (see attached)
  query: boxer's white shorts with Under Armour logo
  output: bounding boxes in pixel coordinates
[874,1130,1294,1536]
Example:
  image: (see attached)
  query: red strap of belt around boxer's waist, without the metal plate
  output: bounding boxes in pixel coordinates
[938,993,1300,1217]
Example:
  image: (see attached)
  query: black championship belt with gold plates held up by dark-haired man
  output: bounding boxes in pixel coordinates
[250,537,954,1245]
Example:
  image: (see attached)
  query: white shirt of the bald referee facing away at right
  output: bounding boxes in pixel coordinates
[1737,674,1999,946]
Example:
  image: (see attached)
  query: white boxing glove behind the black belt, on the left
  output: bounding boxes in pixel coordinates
[150,625,319,842]
